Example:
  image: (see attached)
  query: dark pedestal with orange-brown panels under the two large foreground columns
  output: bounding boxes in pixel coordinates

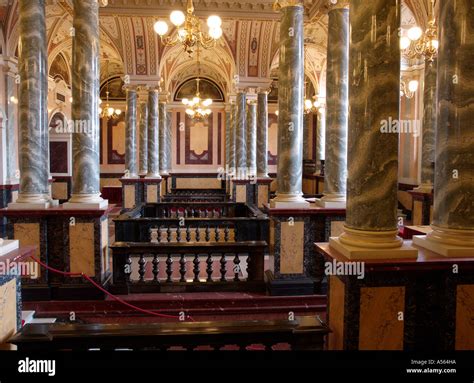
[315,241,474,352]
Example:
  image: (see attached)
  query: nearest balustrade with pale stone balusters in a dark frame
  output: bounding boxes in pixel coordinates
[110,241,267,294]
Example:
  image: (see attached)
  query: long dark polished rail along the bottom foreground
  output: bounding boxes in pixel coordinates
[10,317,330,351]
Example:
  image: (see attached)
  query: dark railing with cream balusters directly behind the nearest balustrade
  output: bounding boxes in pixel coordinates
[114,202,269,243]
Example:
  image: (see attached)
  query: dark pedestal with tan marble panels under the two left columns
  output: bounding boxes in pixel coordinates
[0,205,111,300]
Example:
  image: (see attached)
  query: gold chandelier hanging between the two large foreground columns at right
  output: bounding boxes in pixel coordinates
[400,0,439,62]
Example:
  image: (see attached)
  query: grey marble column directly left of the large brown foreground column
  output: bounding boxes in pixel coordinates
[323,8,349,204]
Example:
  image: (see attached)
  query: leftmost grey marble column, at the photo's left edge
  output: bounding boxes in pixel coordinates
[17,0,49,204]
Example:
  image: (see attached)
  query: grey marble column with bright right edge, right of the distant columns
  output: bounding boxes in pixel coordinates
[272,4,305,206]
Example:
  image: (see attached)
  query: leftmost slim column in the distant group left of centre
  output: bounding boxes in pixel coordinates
[125,89,138,178]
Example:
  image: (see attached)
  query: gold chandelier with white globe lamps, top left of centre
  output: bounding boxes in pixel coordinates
[154,0,223,55]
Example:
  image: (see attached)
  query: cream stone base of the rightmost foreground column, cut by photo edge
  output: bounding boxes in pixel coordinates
[413,225,474,257]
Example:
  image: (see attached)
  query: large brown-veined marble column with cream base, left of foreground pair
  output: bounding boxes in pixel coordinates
[330,0,417,259]
